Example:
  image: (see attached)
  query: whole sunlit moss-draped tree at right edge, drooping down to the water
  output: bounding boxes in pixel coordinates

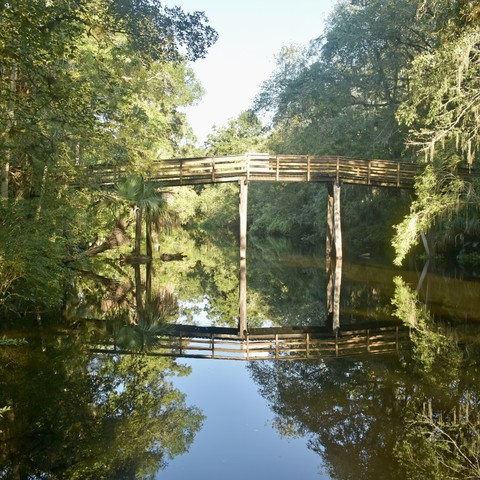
[393,0,480,263]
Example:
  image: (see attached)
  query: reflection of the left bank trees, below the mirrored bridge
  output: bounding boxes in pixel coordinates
[0,320,202,479]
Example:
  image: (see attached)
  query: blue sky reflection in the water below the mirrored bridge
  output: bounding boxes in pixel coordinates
[157,360,330,480]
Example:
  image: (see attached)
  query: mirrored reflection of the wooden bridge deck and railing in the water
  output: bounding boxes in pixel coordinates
[93,325,409,361]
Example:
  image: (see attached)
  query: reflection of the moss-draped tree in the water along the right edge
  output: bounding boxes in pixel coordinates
[392,278,480,480]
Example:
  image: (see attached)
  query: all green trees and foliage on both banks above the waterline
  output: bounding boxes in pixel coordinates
[0,0,480,311]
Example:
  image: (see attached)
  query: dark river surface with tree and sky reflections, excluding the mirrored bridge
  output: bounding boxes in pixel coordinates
[0,237,480,480]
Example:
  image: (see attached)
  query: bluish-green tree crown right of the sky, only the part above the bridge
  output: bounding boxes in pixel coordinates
[256,0,428,158]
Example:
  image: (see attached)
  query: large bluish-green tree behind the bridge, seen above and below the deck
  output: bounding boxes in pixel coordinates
[251,0,434,254]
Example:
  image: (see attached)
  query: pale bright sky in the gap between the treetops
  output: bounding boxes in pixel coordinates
[163,0,337,144]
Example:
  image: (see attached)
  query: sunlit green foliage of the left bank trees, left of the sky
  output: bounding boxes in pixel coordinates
[0,0,217,308]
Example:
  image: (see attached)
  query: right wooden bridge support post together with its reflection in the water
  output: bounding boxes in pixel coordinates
[326,182,342,330]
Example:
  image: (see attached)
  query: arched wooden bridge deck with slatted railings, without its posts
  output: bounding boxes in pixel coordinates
[91,154,432,188]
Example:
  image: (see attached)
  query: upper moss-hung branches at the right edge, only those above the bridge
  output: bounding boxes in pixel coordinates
[399,0,480,164]
